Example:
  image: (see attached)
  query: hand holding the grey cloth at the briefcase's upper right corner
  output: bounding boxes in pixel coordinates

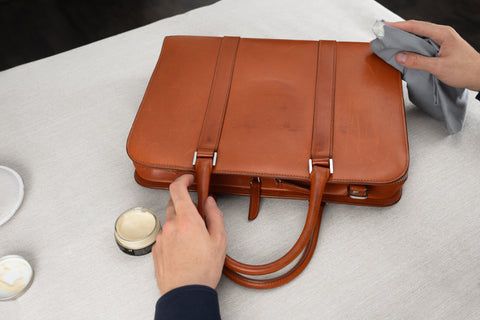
[385,20,480,91]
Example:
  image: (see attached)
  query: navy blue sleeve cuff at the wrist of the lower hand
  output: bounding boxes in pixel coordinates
[155,285,220,320]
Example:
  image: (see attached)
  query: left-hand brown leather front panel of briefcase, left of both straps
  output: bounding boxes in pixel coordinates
[127,37,222,173]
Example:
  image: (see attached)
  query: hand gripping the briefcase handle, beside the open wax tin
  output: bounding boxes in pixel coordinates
[152,175,227,294]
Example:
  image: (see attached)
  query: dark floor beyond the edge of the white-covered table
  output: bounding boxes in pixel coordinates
[0,0,480,70]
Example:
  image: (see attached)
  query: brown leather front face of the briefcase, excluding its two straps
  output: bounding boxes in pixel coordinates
[127,36,409,184]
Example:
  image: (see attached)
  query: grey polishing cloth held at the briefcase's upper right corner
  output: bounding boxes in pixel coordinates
[370,21,468,134]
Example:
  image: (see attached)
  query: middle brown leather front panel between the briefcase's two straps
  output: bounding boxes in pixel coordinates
[214,39,317,179]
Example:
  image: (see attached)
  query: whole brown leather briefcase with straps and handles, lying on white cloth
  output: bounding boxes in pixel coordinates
[127,36,409,288]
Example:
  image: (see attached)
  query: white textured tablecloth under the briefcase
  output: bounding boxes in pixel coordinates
[0,0,480,320]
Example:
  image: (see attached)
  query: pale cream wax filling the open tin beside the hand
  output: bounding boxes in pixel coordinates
[117,209,155,240]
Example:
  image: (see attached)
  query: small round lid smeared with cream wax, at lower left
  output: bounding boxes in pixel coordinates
[0,255,33,301]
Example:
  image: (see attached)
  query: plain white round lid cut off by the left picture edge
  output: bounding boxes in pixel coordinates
[0,166,24,226]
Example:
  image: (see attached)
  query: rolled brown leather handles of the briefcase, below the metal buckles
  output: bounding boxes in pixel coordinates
[196,158,330,289]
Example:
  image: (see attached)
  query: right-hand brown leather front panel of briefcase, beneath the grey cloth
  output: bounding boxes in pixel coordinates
[330,42,409,184]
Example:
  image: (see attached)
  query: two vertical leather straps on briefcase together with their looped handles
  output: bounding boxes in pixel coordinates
[195,38,336,289]
